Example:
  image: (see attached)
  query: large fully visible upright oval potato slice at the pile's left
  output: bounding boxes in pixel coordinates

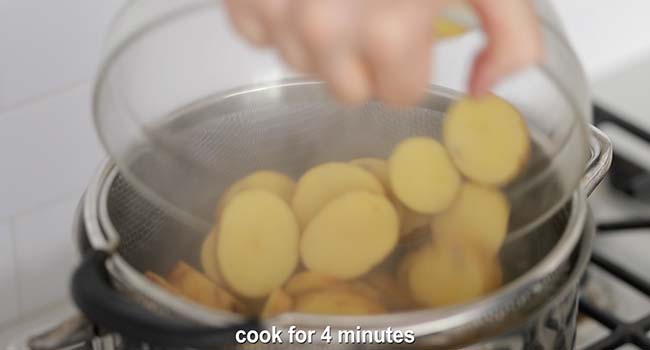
[217,190,300,298]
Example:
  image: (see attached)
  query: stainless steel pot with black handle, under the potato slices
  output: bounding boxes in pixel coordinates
[72,128,612,349]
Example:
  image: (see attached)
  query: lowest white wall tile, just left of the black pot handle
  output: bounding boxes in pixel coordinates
[14,198,78,314]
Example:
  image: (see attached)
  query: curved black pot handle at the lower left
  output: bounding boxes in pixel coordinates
[72,250,261,349]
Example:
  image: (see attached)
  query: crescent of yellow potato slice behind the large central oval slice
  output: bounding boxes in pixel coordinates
[292,163,384,228]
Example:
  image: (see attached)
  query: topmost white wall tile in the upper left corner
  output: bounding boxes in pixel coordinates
[0,0,124,109]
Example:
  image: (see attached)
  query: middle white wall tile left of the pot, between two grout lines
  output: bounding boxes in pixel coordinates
[0,84,102,218]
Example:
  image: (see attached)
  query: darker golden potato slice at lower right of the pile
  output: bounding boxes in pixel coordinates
[408,244,486,307]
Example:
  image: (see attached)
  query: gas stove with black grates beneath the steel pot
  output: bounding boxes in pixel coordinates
[8,107,650,350]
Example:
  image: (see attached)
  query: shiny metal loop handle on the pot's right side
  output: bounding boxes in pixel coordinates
[580,125,613,195]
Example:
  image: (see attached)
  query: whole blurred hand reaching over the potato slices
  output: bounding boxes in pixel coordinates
[226,0,542,105]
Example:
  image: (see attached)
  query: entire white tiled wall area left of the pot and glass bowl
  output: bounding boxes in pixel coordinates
[0,0,127,329]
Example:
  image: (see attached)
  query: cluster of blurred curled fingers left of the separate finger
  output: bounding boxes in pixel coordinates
[226,0,442,105]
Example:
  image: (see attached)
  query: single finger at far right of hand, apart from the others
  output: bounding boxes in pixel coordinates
[469,0,542,96]
